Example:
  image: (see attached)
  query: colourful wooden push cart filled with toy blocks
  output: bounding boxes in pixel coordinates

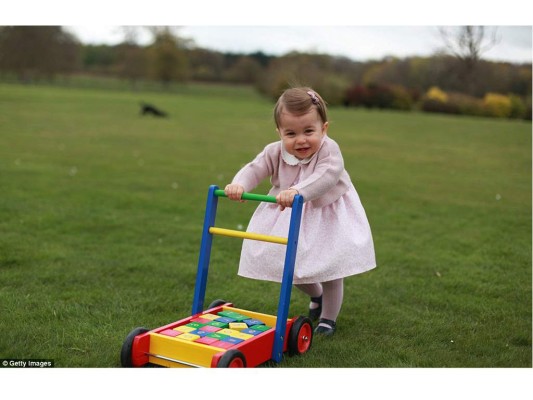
[120,185,313,368]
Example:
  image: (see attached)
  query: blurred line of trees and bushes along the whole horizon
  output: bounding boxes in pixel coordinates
[0,26,532,119]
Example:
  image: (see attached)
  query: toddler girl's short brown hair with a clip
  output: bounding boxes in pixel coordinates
[274,87,328,128]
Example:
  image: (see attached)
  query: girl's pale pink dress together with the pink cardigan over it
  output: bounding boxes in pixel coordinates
[232,136,376,284]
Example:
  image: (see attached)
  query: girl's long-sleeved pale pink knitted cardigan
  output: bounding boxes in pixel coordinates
[232,136,353,207]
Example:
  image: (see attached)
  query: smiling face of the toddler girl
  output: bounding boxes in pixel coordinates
[277,108,328,160]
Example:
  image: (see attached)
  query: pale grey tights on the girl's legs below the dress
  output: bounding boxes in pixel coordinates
[294,278,344,321]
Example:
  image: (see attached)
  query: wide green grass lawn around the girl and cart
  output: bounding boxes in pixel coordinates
[0,84,532,367]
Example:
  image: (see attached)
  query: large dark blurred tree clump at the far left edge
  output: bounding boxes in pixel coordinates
[0,26,80,82]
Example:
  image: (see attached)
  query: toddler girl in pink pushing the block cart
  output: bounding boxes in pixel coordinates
[224,87,376,335]
